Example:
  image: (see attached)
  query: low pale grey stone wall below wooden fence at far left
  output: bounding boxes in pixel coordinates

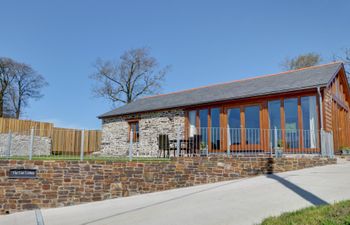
[0,133,51,156]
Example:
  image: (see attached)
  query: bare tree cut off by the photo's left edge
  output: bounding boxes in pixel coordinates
[0,57,17,117]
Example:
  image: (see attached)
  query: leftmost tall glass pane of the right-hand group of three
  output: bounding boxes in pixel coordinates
[268,100,283,148]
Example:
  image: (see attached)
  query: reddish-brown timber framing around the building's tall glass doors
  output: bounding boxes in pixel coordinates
[184,90,320,151]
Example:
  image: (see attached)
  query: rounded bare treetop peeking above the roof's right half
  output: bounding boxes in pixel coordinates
[281,53,322,70]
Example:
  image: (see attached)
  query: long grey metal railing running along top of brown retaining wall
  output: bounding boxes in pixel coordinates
[0,127,334,160]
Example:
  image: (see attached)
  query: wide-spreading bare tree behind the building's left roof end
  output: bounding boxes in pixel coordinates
[90,48,169,104]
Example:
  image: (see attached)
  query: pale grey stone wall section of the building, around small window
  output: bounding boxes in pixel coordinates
[99,110,185,156]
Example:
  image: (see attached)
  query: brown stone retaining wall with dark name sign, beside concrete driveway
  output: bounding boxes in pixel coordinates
[0,157,336,214]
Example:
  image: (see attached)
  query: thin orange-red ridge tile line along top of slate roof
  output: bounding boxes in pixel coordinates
[140,61,343,99]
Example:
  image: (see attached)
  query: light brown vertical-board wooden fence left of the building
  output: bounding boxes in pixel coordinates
[0,118,101,155]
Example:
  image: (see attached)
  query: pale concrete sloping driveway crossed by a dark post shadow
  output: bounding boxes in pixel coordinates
[0,158,350,225]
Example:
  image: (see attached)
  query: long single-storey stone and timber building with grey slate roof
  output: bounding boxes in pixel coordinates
[99,62,350,156]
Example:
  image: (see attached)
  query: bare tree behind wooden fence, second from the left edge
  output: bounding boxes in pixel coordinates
[8,63,48,119]
